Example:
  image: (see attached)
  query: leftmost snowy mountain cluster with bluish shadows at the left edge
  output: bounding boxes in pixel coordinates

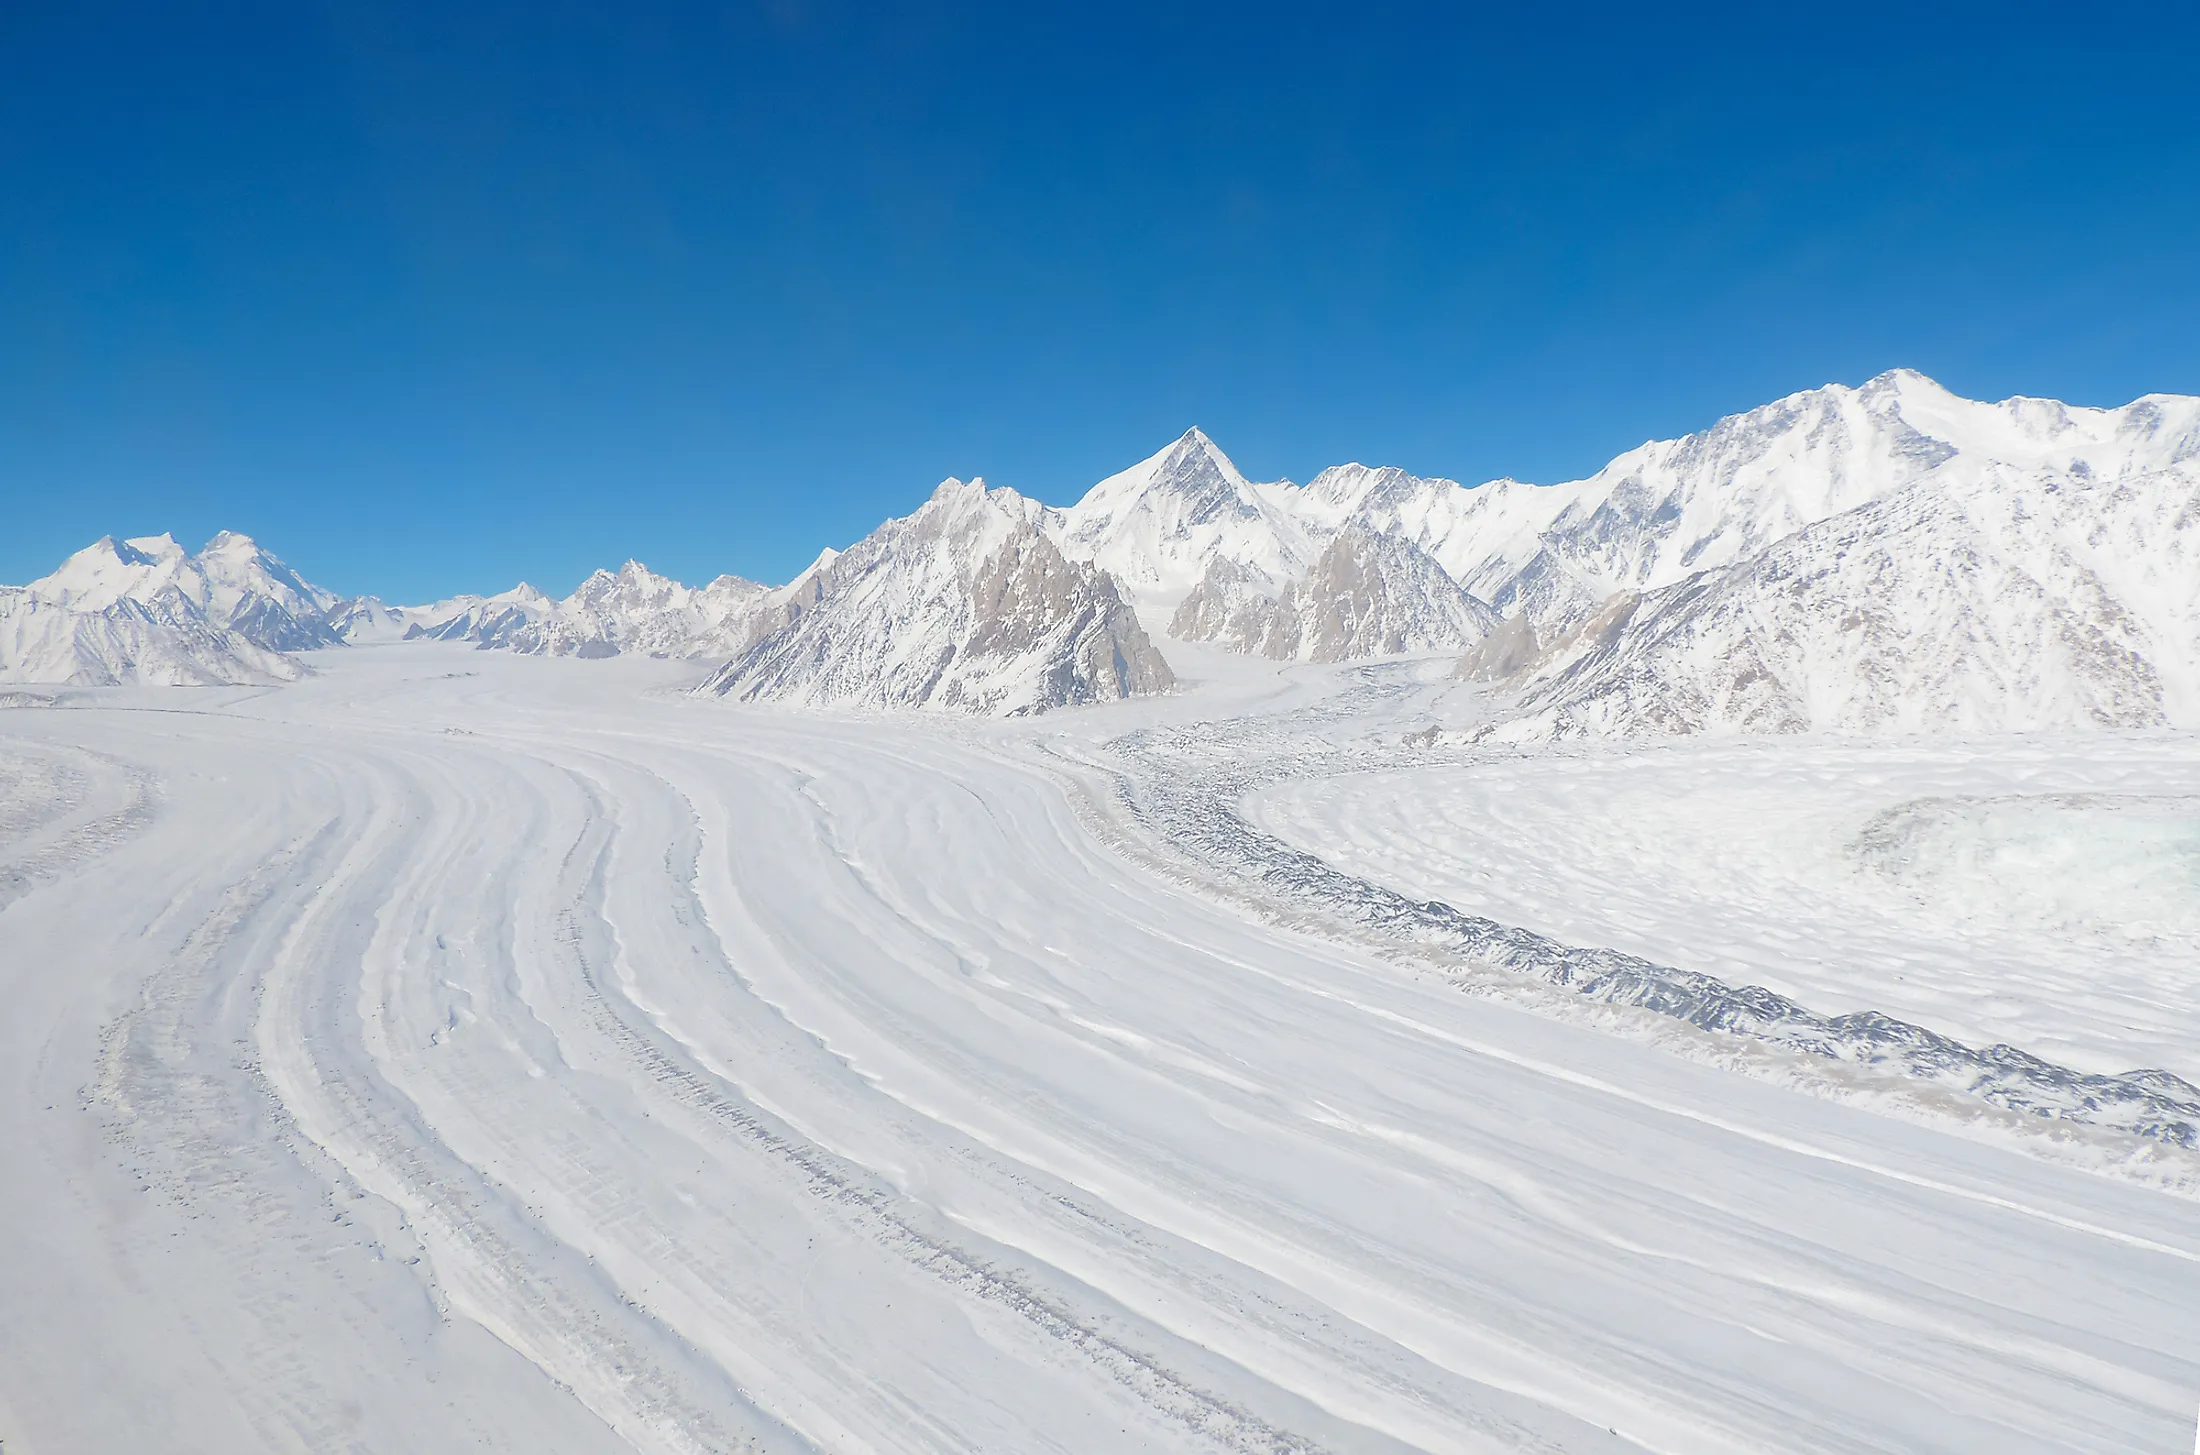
[0,530,341,687]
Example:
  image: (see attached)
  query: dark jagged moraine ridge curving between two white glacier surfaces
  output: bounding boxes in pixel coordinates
[1086,682,2200,1149]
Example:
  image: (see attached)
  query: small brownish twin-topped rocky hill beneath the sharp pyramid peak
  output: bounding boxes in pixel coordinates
[1168,524,1500,663]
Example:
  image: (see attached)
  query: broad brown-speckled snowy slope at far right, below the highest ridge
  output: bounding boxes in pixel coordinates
[1498,460,2200,737]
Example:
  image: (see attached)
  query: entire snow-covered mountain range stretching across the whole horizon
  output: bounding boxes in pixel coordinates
[0,370,2200,721]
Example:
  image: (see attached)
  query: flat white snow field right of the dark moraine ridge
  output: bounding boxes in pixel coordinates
[1247,735,2200,1083]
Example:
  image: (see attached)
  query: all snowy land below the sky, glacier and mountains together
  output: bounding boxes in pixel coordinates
[0,372,2200,1455]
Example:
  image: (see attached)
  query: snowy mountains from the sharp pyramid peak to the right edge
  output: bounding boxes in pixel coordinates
[1038,370,2200,737]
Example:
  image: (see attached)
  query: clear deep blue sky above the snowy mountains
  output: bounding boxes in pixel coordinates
[0,0,2200,599]
